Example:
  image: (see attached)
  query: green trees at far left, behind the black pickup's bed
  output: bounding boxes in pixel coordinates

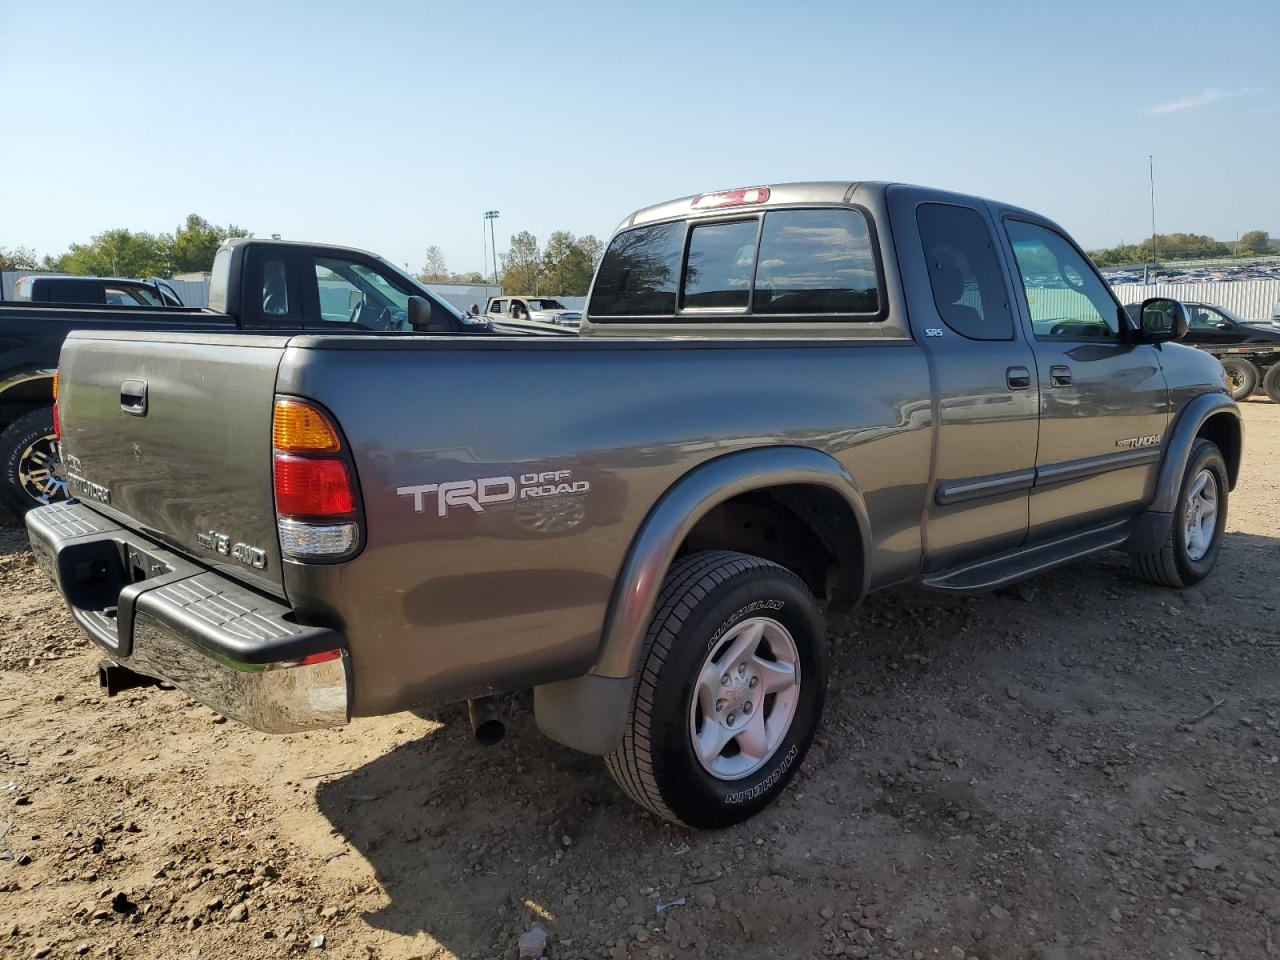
[0,214,250,276]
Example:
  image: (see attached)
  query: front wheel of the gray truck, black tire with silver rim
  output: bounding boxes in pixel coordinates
[1133,439,1228,588]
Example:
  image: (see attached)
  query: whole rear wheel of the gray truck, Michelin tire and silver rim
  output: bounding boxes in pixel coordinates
[605,550,828,828]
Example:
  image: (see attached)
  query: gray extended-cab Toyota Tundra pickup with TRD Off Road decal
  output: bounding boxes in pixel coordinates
[27,183,1242,827]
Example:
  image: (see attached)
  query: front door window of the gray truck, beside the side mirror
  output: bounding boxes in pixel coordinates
[1005,220,1120,340]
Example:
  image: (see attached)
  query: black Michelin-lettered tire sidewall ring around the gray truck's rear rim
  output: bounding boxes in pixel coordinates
[650,567,828,827]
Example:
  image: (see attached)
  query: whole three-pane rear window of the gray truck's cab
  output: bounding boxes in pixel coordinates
[589,209,882,320]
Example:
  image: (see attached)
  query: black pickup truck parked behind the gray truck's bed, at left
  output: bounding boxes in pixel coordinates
[0,239,492,516]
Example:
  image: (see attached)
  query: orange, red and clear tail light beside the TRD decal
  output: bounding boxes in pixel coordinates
[271,397,360,559]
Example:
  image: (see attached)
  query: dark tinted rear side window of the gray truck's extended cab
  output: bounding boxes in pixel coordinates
[915,204,1014,340]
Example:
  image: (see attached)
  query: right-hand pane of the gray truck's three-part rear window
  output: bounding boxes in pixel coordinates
[753,210,881,314]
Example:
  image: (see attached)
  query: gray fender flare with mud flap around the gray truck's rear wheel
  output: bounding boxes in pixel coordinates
[534,447,870,754]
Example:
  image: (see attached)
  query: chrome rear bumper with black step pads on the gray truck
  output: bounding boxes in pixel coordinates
[27,500,351,733]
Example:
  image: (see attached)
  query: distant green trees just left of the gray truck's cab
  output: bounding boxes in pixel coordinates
[417,230,604,297]
